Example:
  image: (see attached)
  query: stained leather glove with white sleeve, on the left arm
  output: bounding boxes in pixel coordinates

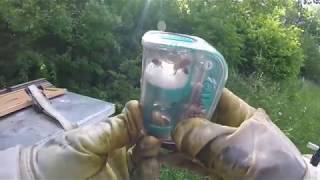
[0,101,148,180]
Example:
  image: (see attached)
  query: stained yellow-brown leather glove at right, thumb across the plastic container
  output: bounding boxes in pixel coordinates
[166,89,320,180]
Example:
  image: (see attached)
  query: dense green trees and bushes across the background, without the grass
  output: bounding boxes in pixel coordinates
[0,0,316,100]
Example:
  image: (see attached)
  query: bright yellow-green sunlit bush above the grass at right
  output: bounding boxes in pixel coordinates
[242,17,304,80]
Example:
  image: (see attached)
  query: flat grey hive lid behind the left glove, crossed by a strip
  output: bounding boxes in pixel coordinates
[0,92,115,150]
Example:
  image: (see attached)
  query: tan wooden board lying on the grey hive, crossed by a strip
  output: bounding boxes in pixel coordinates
[0,87,66,117]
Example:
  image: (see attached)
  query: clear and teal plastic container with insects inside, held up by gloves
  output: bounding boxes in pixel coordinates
[140,31,228,139]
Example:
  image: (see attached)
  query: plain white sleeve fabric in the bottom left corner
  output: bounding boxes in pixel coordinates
[0,146,20,180]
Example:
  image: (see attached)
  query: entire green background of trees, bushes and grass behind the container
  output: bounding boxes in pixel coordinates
[0,0,320,179]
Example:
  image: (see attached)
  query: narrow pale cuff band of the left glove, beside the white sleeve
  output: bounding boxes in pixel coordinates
[19,147,36,180]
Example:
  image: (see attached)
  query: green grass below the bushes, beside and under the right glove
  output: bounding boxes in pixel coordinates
[160,72,320,180]
